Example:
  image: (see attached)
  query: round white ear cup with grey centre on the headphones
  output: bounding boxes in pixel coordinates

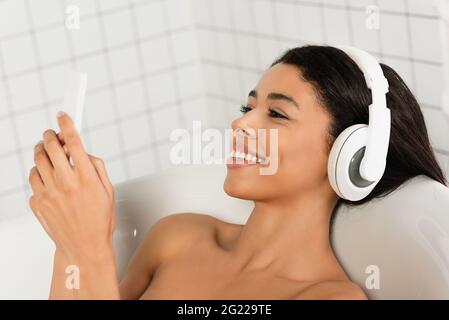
[327,124,378,201]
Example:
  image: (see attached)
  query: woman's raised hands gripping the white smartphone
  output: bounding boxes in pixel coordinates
[29,113,115,261]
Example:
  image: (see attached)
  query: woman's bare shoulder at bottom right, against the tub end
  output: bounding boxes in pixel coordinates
[295,280,368,300]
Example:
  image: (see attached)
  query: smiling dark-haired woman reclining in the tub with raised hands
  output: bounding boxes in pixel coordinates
[30,46,445,299]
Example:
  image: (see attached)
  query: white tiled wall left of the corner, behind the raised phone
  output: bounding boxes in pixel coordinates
[0,0,207,220]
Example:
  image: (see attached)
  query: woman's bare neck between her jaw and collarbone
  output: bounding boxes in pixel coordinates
[231,190,345,281]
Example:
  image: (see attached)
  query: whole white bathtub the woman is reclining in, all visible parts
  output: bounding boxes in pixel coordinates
[0,165,449,299]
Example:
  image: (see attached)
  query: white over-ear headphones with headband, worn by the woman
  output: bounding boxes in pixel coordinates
[327,46,391,201]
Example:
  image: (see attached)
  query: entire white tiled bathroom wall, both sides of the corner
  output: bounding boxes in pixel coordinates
[0,0,449,220]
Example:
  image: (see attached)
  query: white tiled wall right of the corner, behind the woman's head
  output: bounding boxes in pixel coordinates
[193,0,449,173]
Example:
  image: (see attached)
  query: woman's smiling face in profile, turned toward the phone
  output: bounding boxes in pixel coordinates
[224,63,330,200]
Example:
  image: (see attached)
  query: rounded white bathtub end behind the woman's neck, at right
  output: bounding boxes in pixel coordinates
[331,175,449,299]
